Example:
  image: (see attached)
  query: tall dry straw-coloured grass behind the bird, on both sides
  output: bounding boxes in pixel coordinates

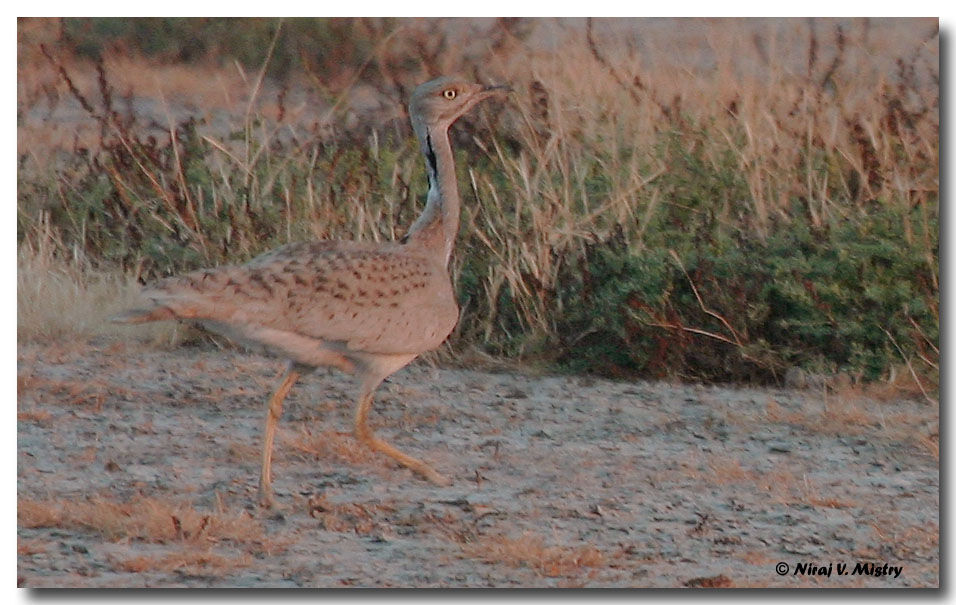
[18,19,939,386]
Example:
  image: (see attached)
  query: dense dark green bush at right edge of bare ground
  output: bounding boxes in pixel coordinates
[556,196,939,381]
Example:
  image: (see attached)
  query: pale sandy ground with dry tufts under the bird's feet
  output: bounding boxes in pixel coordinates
[17,344,939,587]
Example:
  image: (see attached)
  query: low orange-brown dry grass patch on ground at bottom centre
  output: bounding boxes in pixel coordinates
[462,533,605,577]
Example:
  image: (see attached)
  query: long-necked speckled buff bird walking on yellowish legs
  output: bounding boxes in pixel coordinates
[113,76,511,508]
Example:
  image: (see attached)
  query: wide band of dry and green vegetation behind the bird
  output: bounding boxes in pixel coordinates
[18,20,939,386]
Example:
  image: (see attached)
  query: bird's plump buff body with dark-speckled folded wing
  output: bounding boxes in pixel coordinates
[137,242,458,354]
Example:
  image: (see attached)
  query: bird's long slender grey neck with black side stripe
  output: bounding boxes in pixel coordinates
[405,127,461,267]
